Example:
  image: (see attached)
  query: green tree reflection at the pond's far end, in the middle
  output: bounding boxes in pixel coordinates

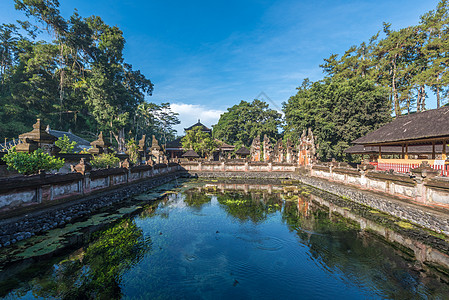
[217,192,282,223]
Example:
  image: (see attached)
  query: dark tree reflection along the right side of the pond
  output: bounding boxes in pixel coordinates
[283,197,448,299]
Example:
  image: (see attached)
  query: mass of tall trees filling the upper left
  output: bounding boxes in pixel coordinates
[0,0,179,152]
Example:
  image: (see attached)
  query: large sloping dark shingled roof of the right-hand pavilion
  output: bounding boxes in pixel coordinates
[353,106,449,145]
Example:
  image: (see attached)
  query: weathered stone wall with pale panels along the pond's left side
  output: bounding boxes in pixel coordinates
[0,164,180,212]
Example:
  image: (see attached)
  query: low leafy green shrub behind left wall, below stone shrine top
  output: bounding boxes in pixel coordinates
[2,148,64,175]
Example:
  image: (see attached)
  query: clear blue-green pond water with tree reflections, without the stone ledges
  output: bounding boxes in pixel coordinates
[0,182,449,299]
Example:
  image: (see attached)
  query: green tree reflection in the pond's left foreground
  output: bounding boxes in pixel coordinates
[25,219,150,299]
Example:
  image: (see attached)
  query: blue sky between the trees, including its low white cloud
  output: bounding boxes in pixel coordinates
[0,0,438,134]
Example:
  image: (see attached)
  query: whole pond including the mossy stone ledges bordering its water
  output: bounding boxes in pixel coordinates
[0,179,449,299]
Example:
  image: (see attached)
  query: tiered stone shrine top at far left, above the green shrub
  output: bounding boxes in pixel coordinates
[16,119,61,154]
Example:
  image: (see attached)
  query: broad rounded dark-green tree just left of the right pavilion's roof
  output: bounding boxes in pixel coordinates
[283,78,391,161]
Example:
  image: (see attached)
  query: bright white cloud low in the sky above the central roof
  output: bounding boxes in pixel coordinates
[170,103,224,136]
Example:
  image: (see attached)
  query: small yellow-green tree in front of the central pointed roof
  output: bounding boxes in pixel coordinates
[181,126,218,157]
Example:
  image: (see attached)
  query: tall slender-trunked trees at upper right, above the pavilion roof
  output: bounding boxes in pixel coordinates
[321,0,449,116]
